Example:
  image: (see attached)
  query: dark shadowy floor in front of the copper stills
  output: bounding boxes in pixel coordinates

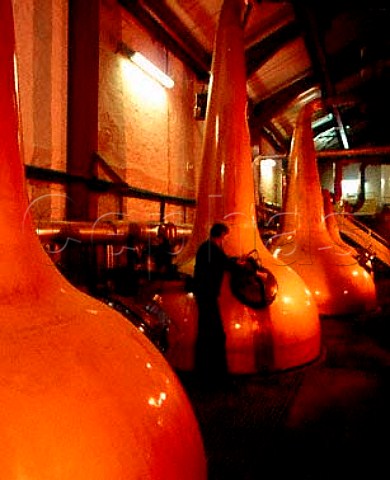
[179,278,390,480]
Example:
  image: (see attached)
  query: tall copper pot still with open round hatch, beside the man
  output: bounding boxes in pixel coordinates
[163,0,321,373]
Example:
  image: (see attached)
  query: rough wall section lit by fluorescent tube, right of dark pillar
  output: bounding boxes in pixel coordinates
[99,2,202,221]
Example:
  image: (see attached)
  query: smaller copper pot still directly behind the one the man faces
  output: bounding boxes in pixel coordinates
[273,100,376,315]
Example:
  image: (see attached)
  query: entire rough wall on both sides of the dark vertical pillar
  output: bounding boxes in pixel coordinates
[14,0,203,222]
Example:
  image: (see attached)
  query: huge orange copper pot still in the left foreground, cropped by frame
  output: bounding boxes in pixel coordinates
[0,0,206,480]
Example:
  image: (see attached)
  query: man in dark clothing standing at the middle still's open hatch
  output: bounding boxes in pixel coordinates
[194,223,229,386]
